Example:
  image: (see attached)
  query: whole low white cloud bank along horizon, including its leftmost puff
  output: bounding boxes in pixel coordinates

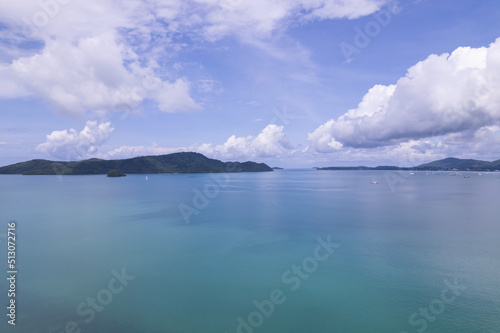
[35,121,500,167]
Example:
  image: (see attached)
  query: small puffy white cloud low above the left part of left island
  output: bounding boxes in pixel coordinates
[35,121,114,160]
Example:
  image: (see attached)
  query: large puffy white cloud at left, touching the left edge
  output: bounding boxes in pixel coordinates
[0,34,201,116]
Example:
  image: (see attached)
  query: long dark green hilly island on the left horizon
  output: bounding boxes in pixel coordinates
[0,152,273,175]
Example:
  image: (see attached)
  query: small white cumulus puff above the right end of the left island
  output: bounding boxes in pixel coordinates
[193,125,294,159]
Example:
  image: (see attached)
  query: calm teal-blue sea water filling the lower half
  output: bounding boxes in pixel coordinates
[0,170,500,333]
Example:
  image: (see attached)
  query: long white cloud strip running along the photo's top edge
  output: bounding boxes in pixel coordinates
[0,0,390,41]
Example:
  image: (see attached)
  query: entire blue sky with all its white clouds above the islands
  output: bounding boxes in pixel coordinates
[0,0,500,168]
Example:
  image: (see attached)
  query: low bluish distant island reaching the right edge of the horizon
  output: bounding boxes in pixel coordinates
[315,157,500,171]
